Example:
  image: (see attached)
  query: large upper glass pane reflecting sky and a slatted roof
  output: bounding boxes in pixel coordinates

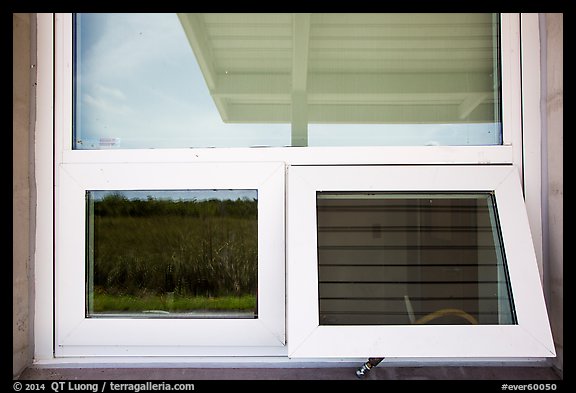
[73,13,502,149]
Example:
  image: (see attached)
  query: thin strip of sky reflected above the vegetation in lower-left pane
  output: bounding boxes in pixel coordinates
[89,190,258,201]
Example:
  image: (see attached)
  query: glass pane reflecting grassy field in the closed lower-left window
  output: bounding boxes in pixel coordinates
[86,190,258,318]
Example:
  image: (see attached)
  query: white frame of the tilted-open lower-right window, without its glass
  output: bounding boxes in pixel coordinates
[287,165,556,358]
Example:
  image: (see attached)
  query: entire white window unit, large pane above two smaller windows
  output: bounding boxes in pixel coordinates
[37,14,553,358]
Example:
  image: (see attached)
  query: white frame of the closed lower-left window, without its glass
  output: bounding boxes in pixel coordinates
[55,163,285,356]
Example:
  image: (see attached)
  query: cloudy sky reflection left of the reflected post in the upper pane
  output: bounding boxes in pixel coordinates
[76,14,290,148]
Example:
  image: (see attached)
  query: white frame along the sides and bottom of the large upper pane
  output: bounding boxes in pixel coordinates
[54,13,522,166]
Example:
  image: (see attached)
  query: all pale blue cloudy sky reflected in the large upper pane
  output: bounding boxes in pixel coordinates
[75,13,501,148]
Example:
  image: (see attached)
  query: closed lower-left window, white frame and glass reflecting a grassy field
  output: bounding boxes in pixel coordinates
[55,163,285,356]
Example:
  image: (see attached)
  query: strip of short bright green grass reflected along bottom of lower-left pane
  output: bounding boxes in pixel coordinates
[94,293,256,313]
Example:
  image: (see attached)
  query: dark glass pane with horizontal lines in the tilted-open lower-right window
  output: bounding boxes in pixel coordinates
[317,192,516,325]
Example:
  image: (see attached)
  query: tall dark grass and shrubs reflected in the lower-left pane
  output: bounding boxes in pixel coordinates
[88,197,258,298]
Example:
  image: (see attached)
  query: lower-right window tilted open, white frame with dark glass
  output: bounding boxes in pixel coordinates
[287,166,554,357]
